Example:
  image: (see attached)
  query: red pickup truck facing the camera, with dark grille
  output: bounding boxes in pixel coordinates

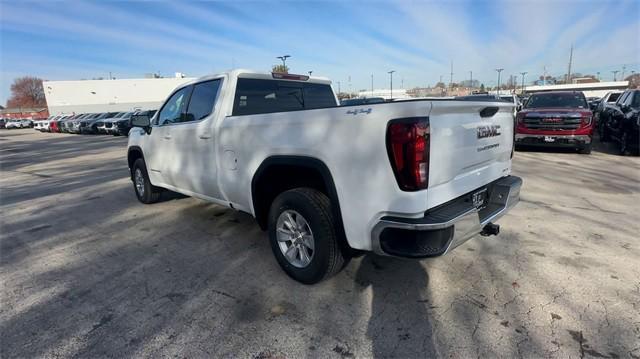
[515,91,594,154]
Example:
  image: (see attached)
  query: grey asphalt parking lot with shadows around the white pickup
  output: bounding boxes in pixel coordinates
[0,129,640,358]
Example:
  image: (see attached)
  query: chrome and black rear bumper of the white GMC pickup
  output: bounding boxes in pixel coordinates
[372,176,522,258]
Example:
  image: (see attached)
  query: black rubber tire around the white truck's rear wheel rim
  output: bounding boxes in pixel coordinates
[268,188,350,284]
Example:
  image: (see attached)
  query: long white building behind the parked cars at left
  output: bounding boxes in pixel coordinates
[42,77,193,115]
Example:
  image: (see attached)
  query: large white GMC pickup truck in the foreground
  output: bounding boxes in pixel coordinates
[128,70,522,284]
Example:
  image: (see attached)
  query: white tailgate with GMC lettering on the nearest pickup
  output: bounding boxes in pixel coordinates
[428,101,514,208]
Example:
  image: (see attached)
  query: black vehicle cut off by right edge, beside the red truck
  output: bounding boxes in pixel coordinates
[599,89,640,155]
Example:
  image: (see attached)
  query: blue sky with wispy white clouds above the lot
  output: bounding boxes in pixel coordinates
[0,0,640,103]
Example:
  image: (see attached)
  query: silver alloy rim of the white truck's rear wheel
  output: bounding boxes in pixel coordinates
[276,209,315,268]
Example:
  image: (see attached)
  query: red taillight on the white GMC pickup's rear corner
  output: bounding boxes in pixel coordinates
[387,117,429,191]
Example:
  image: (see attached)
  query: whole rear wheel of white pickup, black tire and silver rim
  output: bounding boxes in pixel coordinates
[269,188,349,284]
